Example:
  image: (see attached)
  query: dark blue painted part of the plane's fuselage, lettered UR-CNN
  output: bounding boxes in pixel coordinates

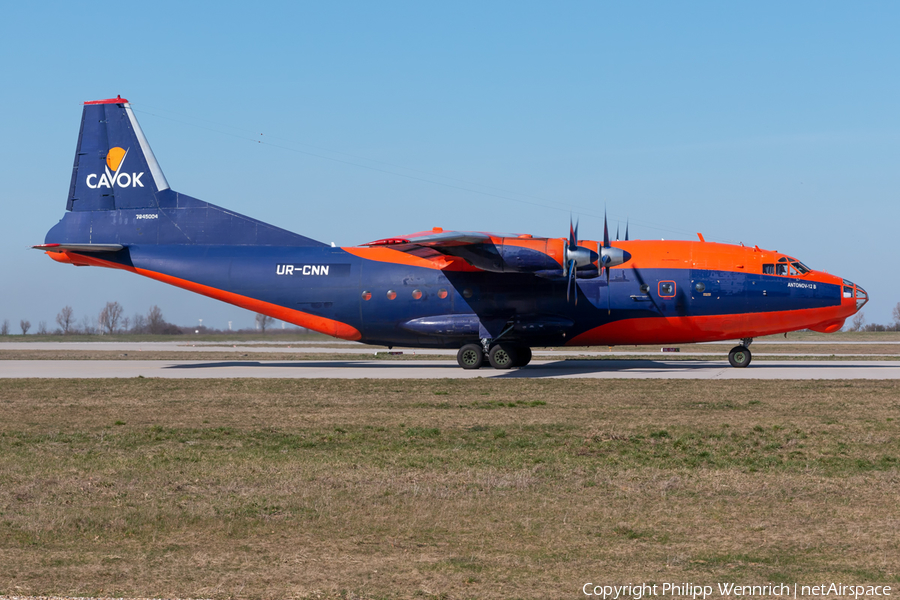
[105,244,841,347]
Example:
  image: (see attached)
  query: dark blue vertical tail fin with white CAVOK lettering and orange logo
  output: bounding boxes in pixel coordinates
[45,96,325,246]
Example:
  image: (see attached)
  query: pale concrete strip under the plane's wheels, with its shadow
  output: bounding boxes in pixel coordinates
[0,360,900,379]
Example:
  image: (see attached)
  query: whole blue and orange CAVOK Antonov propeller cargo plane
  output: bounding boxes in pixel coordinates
[35,97,868,369]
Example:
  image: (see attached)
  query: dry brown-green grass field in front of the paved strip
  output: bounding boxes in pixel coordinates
[0,379,900,598]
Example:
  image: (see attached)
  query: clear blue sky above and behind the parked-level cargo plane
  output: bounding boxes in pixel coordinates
[0,2,900,329]
